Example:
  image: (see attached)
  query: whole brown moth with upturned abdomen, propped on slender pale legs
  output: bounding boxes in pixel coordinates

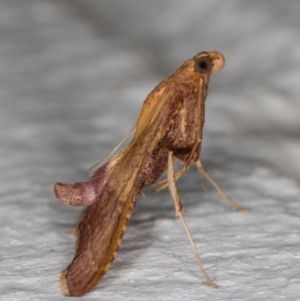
[54,51,246,296]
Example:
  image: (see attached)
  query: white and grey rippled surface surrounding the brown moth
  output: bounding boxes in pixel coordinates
[0,0,300,301]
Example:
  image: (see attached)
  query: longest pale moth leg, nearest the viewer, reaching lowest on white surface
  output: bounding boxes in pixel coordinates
[168,152,218,288]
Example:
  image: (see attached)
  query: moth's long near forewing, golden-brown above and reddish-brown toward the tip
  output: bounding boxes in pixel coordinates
[60,91,185,296]
